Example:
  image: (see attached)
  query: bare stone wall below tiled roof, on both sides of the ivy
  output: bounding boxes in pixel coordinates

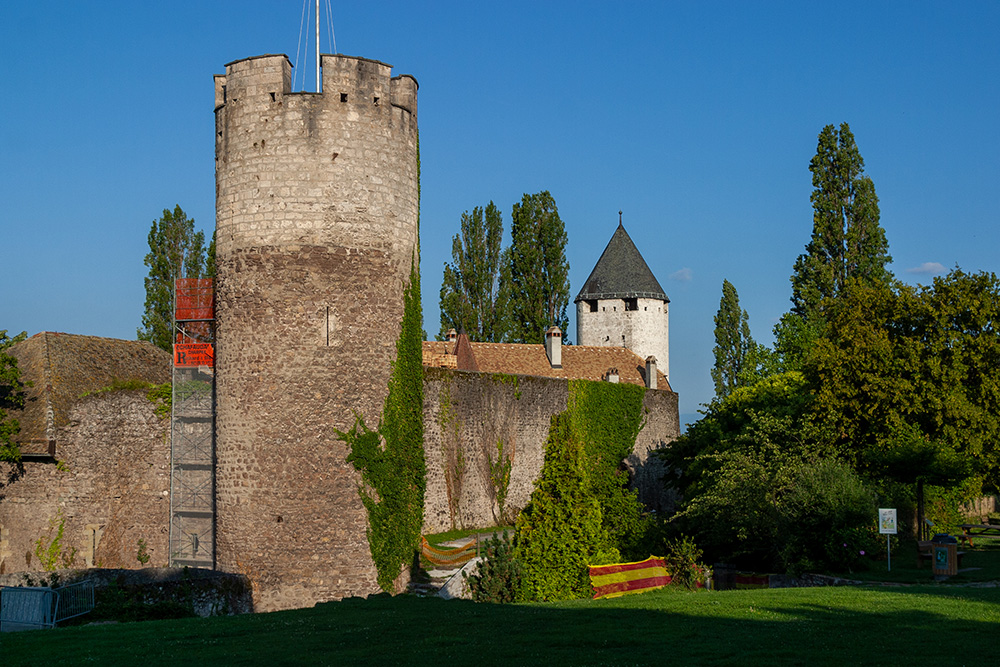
[424,368,679,533]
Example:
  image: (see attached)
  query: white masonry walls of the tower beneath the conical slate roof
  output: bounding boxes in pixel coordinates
[576,299,670,379]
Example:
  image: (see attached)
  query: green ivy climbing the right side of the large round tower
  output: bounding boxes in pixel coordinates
[337,134,427,592]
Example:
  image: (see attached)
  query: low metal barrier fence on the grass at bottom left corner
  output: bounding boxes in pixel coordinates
[0,581,94,632]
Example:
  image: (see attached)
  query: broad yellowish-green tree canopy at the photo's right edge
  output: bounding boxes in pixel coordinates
[804,269,1000,489]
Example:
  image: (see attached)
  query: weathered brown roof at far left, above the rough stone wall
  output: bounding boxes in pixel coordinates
[10,331,171,453]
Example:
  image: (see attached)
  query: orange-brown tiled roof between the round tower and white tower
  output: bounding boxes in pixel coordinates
[424,337,672,391]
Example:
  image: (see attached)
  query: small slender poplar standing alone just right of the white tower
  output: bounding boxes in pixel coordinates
[712,280,757,399]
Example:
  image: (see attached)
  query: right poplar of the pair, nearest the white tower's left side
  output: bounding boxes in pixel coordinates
[503,190,569,343]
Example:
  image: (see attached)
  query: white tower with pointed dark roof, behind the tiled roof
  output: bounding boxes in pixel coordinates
[575,220,670,379]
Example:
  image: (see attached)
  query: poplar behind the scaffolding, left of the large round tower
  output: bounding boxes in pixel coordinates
[136,206,205,352]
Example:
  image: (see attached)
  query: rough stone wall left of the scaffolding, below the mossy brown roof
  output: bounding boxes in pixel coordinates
[0,390,170,574]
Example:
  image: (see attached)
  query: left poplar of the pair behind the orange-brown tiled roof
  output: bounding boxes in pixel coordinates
[440,201,506,343]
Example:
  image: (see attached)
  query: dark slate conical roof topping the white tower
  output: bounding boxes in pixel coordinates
[574,222,670,303]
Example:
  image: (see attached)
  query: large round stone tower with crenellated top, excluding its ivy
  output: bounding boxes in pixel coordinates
[215,55,418,610]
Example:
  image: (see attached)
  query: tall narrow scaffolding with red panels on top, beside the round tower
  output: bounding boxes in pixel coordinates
[170,278,215,569]
